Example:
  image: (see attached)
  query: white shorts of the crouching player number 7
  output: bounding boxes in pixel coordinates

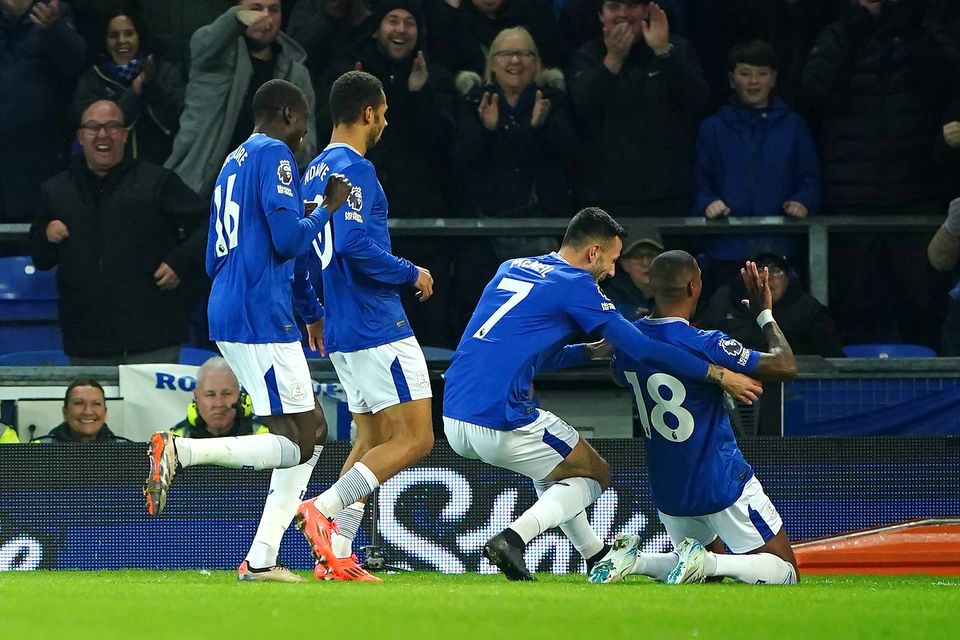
[443,409,580,480]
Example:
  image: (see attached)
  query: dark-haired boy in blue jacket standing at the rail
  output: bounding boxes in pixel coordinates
[693,40,821,296]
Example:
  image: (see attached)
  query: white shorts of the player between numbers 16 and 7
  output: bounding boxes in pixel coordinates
[330,336,433,413]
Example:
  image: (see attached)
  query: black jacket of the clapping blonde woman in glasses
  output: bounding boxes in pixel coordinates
[453,69,576,217]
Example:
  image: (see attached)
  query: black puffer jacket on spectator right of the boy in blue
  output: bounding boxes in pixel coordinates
[803,3,958,206]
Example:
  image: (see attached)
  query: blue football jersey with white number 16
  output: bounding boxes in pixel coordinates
[206,133,322,344]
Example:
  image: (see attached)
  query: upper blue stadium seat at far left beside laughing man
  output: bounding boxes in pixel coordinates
[0,256,63,353]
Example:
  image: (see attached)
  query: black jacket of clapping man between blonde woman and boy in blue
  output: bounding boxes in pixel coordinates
[567,36,710,215]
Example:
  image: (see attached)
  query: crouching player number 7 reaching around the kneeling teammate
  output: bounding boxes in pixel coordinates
[443,207,761,580]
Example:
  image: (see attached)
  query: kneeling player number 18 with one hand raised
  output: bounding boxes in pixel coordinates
[590,251,799,584]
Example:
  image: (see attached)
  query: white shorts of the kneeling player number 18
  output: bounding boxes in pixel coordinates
[657,476,783,553]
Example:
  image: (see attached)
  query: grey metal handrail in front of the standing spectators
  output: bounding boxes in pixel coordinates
[0,216,943,304]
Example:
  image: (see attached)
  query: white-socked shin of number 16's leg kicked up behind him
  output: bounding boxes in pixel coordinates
[176,433,300,469]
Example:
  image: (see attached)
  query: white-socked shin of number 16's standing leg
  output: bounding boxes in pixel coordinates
[247,445,323,568]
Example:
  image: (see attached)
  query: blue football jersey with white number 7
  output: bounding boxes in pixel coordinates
[443,253,621,430]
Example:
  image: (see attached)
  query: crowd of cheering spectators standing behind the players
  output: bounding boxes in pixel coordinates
[0,0,960,364]
